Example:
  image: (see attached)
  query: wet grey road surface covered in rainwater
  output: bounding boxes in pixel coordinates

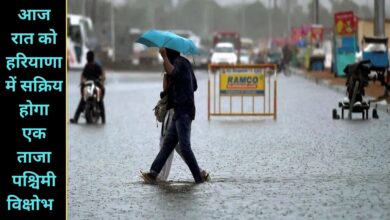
[68,71,390,220]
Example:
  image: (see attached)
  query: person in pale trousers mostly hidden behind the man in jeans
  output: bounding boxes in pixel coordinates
[157,73,209,181]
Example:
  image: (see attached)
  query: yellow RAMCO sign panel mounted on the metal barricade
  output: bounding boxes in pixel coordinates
[219,69,265,96]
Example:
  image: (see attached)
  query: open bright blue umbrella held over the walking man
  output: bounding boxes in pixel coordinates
[136,29,199,55]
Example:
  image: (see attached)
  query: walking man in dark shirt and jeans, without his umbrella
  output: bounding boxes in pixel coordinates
[142,48,205,183]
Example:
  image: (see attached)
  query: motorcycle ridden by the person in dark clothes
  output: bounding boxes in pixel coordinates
[83,80,102,124]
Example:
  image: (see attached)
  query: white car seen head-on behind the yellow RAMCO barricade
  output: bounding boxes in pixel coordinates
[211,43,237,65]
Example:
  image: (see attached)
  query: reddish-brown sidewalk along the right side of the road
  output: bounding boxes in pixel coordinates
[290,67,390,113]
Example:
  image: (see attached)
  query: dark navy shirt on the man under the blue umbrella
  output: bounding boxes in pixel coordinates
[168,56,198,120]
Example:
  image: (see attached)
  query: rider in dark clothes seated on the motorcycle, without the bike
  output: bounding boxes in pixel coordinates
[70,51,106,124]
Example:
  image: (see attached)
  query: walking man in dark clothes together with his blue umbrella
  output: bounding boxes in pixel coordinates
[136,29,208,183]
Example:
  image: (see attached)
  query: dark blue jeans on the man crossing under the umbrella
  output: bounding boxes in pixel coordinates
[150,114,203,183]
